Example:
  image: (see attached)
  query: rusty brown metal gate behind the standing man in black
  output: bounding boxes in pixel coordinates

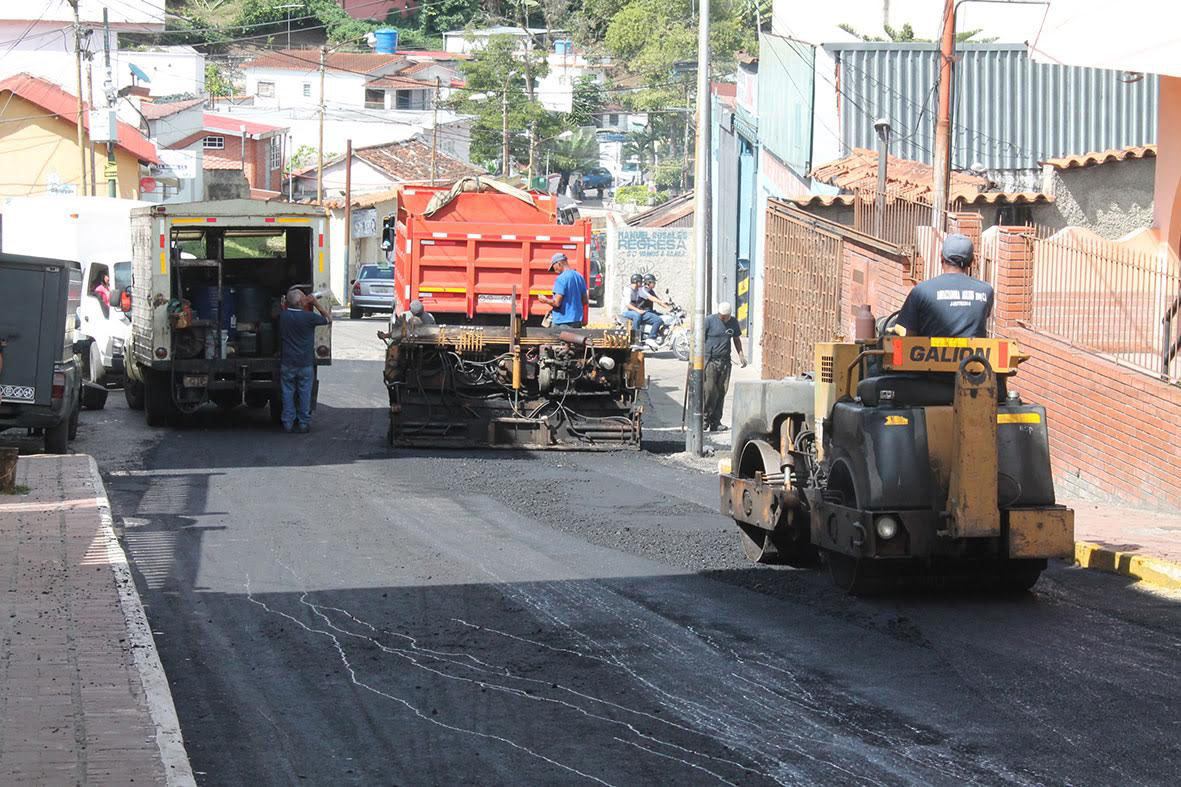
[763,200,844,379]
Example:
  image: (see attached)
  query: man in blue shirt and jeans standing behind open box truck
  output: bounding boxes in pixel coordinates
[279,287,332,434]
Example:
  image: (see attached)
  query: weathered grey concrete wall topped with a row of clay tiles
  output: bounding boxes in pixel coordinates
[1037,158,1156,240]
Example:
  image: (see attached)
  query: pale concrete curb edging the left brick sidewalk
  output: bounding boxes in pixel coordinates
[86,456,197,787]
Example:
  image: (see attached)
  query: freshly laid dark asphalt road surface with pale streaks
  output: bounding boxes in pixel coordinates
[77,320,1181,785]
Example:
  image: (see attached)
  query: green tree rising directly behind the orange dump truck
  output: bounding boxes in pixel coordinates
[446,35,561,171]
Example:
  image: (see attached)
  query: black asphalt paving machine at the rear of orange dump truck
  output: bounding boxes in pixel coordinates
[381,321,645,450]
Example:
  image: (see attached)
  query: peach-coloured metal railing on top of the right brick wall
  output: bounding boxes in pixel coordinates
[1029,228,1181,384]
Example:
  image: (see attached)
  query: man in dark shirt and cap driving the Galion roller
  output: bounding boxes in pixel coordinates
[898,230,993,338]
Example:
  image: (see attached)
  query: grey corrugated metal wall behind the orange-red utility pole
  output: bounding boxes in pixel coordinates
[826,43,1157,170]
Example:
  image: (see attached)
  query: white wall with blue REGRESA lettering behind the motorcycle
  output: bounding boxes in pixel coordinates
[603,223,693,316]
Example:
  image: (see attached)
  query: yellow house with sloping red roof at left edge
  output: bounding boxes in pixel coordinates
[0,73,159,200]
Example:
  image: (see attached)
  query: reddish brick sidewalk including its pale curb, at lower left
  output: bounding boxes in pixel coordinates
[0,455,193,785]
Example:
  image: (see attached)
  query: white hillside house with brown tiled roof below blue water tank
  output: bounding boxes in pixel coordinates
[242,48,457,110]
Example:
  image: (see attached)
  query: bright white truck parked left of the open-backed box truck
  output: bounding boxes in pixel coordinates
[0,195,151,409]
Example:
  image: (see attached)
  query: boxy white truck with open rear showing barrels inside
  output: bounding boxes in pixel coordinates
[124,200,332,425]
